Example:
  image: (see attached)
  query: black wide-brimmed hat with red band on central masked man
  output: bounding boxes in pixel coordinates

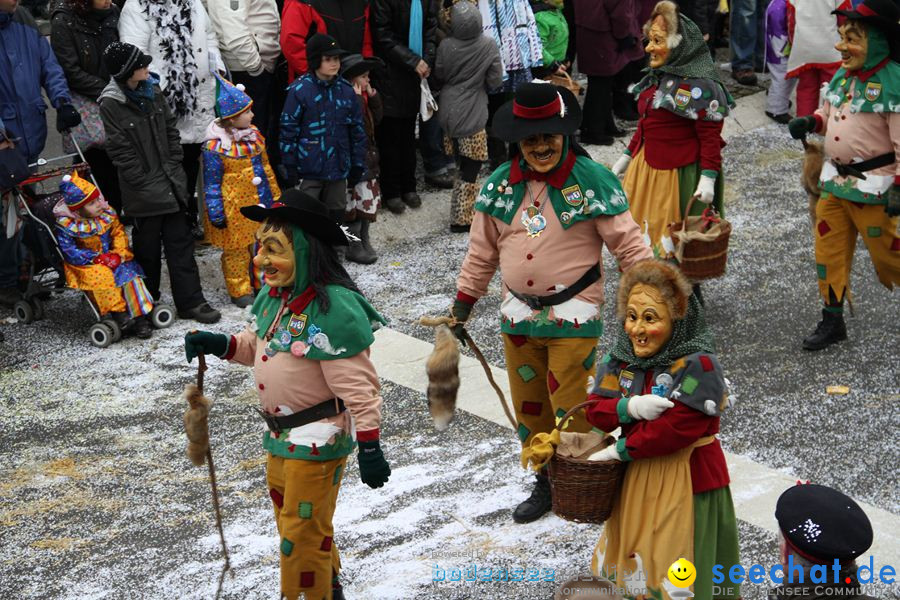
[491,83,581,142]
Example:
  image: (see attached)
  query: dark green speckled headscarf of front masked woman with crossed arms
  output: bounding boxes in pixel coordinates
[609,295,716,370]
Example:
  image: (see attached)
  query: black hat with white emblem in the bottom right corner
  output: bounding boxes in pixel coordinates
[775,484,872,562]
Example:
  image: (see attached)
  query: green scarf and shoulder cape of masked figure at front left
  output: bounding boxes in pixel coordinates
[251,226,387,360]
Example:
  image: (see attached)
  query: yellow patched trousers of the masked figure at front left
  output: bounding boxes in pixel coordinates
[266,454,347,600]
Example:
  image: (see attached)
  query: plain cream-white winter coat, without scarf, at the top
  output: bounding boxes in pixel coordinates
[206,0,281,75]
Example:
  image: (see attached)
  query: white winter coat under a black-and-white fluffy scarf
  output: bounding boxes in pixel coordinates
[119,0,225,144]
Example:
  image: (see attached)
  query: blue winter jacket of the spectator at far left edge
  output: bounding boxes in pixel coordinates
[0,6,71,162]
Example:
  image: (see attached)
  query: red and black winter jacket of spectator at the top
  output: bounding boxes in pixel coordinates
[281,0,375,81]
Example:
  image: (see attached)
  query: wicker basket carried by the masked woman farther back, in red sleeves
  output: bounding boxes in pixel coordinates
[669,196,731,281]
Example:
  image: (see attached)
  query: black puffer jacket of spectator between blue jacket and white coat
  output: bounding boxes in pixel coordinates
[50,4,119,100]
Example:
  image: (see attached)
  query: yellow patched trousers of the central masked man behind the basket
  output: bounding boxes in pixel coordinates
[503,333,597,447]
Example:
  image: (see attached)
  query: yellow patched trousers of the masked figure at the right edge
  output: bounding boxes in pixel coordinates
[816,193,900,302]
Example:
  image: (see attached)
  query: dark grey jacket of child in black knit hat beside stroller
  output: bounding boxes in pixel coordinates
[100,81,187,217]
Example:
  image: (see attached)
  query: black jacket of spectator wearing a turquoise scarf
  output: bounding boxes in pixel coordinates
[369,0,437,118]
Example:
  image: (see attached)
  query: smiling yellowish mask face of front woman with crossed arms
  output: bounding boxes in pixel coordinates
[625,283,673,358]
